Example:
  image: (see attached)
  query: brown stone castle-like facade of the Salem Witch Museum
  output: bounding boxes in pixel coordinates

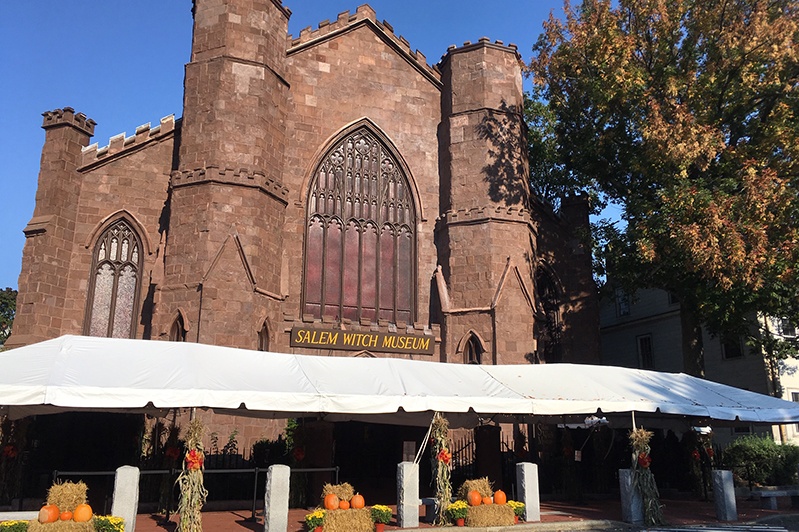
[7,0,599,454]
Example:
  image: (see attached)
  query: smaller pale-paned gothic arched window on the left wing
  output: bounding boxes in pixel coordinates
[85,219,142,338]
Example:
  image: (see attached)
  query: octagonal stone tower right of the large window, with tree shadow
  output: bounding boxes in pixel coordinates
[436,38,535,364]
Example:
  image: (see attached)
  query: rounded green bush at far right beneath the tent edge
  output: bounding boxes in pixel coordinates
[722,436,799,486]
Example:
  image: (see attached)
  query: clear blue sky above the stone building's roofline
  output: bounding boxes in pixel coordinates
[0,0,562,289]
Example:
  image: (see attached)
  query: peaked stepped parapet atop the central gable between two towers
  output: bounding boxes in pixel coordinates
[288,4,440,80]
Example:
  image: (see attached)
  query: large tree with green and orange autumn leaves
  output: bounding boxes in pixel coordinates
[529,0,799,375]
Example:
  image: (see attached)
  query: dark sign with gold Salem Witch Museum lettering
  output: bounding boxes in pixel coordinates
[291,327,435,355]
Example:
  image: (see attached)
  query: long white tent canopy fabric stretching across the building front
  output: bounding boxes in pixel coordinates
[0,336,799,426]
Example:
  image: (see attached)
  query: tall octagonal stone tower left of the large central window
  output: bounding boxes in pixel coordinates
[156,0,290,348]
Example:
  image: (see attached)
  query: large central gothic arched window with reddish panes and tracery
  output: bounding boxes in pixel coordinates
[303,127,416,323]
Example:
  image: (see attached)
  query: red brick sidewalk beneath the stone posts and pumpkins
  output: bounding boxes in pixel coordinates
[136,497,799,532]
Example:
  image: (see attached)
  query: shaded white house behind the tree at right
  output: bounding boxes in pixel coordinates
[599,289,799,443]
